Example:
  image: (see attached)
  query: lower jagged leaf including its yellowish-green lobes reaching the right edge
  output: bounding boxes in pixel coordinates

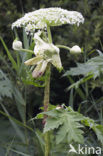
[41,107,103,144]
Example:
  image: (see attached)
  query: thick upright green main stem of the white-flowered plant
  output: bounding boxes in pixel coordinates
[44,26,52,156]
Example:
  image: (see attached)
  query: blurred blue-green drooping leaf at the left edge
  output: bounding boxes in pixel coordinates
[0,70,26,121]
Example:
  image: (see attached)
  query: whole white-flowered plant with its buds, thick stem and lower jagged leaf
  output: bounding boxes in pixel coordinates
[12,8,103,156]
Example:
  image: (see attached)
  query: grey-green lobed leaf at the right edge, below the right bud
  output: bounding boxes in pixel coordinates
[64,54,103,90]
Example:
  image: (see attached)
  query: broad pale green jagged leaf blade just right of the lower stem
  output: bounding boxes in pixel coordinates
[44,108,84,144]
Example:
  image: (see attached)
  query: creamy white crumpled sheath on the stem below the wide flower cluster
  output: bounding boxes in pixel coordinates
[25,33,62,78]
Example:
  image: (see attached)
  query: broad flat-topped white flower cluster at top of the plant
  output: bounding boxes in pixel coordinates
[12,8,84,33]
